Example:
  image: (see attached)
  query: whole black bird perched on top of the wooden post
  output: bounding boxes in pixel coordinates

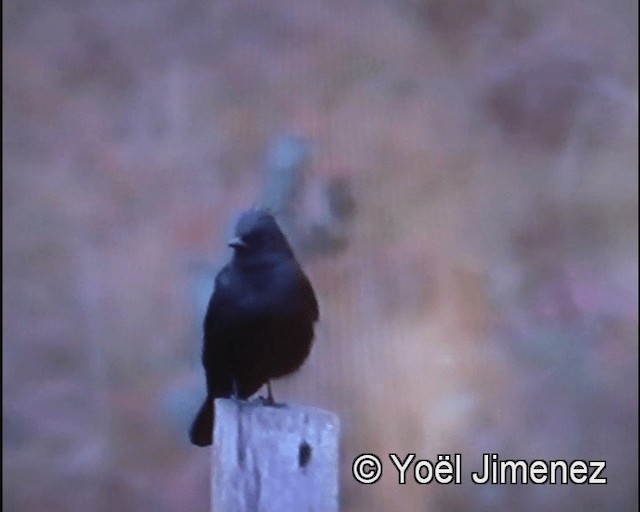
[189,210,318,446]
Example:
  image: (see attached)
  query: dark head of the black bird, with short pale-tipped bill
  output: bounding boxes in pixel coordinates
[228,210,293,259]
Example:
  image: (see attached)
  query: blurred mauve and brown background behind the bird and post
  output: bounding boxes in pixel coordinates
[2,0,638,512]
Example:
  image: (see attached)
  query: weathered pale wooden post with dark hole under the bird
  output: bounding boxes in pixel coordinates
[211,398,340,512]
